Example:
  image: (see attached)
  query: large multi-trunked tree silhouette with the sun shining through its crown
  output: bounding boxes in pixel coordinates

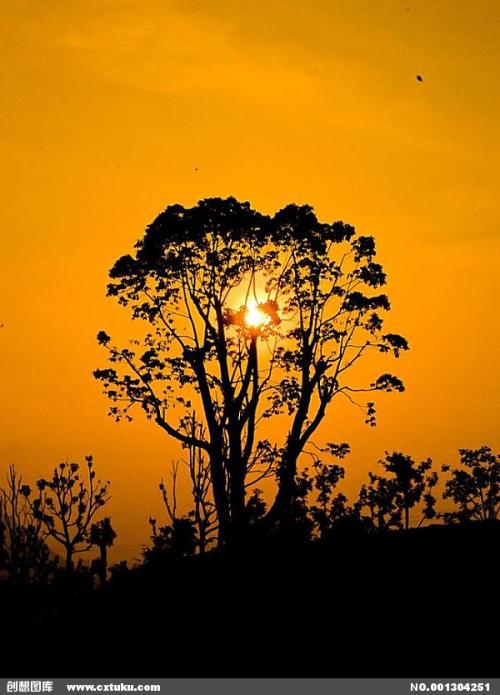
[95,198,408,542]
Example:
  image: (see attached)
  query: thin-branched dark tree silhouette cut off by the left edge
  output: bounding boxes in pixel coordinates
[0,466,57,582]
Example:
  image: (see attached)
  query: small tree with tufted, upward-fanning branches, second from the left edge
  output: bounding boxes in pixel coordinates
[24,456,110,571]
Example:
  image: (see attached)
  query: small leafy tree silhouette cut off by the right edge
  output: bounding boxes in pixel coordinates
[442,446,500,523]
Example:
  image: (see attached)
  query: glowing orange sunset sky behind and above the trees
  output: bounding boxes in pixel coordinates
[0,0,500,558]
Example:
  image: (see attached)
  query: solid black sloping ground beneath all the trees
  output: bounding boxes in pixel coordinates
[0,523,500,678]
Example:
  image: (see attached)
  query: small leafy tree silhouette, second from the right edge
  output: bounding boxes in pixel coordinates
[355,452,438,529]
